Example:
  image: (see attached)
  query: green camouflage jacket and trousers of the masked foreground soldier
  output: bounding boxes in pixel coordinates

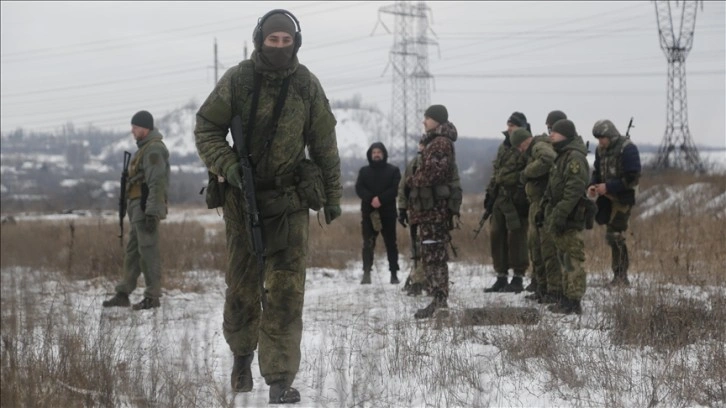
[194,51,342,386]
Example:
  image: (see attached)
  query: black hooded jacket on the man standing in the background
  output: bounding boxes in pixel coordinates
[355,142,401,217]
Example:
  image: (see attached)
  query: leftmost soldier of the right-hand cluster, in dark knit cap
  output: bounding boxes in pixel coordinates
[484,112,530,293]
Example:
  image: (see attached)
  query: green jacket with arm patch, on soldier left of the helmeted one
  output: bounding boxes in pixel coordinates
[543,136,590,233]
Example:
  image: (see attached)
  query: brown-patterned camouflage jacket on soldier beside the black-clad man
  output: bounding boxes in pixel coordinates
[406,122,462,224]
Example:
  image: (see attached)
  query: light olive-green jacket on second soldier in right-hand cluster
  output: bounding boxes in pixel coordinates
[521,135,557,203]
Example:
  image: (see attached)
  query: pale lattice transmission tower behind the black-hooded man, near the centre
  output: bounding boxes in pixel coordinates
[373,1,437,163]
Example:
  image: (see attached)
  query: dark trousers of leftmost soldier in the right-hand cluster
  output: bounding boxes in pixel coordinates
[489,206,529,277]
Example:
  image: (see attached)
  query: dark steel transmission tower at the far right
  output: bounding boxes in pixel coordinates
[655,1,703,172]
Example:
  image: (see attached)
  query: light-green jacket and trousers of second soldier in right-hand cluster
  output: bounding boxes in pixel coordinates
[521,135,562,296]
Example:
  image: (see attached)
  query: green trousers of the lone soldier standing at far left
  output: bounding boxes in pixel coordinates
[116,199,161,299]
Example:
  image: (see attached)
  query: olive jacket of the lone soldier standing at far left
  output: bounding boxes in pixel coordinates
[126,129,171,222]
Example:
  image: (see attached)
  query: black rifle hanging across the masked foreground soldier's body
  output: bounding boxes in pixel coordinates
[229,115,267,309]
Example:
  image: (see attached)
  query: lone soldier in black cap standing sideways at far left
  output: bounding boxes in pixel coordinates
[103,111,170,310]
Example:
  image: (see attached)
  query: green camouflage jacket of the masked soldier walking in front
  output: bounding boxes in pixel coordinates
[194,51,342,205]
